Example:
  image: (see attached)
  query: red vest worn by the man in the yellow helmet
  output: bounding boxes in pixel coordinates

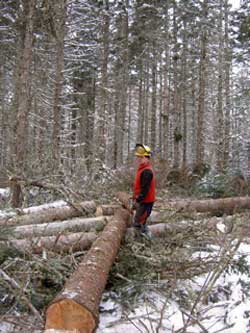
[133,160,155,203]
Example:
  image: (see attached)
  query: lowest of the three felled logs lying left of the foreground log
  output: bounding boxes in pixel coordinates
[0,232,98,254]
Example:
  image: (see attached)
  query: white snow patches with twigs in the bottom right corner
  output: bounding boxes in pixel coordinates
[97,244,250,333]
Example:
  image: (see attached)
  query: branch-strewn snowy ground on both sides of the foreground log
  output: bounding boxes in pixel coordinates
[0,185,250,333]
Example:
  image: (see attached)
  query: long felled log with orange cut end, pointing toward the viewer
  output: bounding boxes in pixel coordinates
[45,209,129,333]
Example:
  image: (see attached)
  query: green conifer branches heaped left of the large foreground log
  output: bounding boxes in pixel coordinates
[0,249,74,314]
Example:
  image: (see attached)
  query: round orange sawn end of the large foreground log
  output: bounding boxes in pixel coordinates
[44,299,97,333]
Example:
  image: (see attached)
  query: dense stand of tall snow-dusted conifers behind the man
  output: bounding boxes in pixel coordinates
[0,0,250,206]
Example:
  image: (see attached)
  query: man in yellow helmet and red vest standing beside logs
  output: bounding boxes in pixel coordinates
[133,144,155,236]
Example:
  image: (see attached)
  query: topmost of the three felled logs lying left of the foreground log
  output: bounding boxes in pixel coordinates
[0,201,96,226]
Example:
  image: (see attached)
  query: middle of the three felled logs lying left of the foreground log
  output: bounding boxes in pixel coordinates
[9,216,108,239]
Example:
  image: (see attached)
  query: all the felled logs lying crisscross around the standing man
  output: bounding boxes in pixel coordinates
[0,193,250,333]
